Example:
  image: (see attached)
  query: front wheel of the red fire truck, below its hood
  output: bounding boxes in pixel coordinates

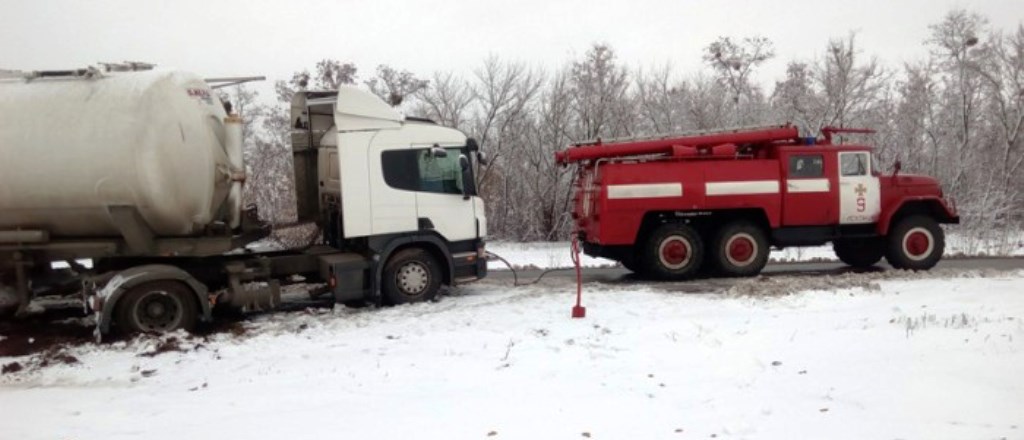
[886,215,946,270]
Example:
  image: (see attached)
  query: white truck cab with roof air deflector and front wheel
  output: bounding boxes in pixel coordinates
[291,86,486,304]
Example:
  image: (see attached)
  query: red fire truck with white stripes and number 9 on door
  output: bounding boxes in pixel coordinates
[555,125,959,279]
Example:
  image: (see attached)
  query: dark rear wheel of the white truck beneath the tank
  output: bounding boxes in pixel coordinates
[115,280,199,334]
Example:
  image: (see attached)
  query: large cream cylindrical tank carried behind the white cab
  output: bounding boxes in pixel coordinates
[0,71,240,237]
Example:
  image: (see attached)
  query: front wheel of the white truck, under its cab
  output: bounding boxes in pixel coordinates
[381,248,441,305]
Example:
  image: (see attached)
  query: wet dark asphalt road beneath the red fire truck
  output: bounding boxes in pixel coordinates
[480,257,1024,292]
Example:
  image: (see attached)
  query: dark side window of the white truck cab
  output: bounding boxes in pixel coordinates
[381,147,463,194]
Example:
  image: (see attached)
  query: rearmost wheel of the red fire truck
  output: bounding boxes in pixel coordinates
[642,223,703,279]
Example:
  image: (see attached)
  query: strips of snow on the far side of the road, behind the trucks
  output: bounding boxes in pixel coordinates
[487,233,1024,270]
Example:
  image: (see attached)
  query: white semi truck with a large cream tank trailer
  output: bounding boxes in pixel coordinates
[0,69,486,333]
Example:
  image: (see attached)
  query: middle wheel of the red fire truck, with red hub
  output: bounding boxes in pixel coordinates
[711,221,768,276]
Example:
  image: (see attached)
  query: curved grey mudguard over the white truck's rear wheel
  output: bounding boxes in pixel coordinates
[96,264,212,334]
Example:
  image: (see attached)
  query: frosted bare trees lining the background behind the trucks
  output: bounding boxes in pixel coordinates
[229,9,1024,247]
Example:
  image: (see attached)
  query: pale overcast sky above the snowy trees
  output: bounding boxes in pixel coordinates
[0,0,1024,93]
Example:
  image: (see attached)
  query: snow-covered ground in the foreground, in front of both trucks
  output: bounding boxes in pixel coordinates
[0,271,1024,440]
